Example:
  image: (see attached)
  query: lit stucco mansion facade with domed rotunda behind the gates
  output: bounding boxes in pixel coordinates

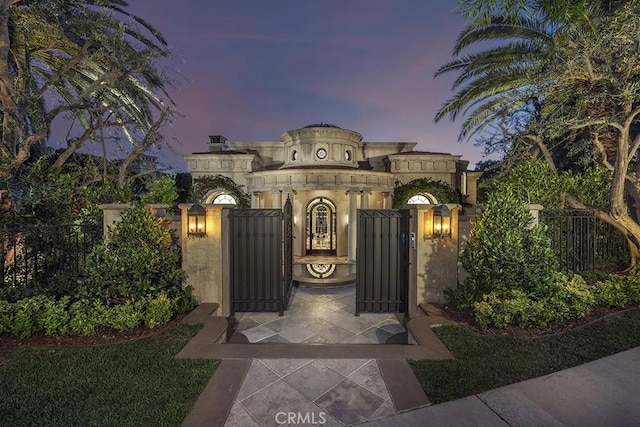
[183,123,478,279]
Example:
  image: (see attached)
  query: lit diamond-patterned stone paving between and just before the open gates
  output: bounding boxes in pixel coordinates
[236,285,405,344]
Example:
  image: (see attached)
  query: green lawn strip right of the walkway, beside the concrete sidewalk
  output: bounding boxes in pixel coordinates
[410,309,640,403]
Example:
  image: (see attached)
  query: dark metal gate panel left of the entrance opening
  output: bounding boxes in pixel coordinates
[230,199,293,315]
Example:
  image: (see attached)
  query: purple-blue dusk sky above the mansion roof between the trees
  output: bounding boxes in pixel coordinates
[128,0,482,170]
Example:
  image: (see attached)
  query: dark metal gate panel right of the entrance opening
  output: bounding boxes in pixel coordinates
[356,209,409,316]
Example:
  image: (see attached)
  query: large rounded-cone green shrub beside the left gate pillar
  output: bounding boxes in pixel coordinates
[87,204,185,304]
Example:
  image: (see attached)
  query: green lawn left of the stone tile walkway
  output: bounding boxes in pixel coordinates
[0,325,218,427]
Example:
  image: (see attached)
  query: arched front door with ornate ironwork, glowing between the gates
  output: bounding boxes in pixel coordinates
[305,197,337,255]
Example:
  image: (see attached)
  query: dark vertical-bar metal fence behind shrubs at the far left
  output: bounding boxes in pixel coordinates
[0,225,102,293]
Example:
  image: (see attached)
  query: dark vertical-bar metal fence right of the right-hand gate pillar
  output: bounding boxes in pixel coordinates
[540,209,629,273]
